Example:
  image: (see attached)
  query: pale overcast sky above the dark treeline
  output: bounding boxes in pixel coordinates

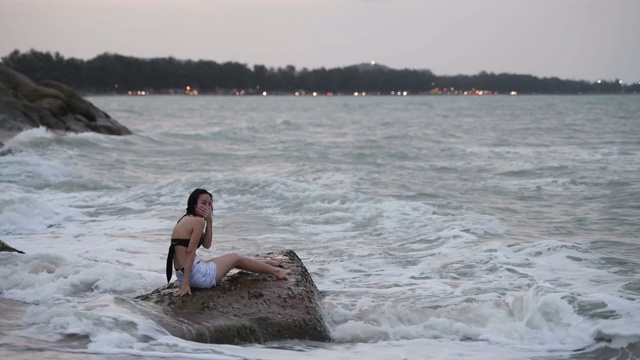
[0,0,640,83]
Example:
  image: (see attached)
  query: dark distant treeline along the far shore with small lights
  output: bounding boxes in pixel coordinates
[2,50,640,94]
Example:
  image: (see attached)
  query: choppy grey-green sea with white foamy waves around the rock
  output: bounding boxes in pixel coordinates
[0,95,640,360]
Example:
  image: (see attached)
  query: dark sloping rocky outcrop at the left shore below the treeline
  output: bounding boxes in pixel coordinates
[0,64,131,147]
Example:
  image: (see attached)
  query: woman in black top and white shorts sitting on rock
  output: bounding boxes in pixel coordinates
[167,189,290,296]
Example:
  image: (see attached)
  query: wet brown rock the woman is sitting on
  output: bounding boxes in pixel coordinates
[129,250,331,344]
